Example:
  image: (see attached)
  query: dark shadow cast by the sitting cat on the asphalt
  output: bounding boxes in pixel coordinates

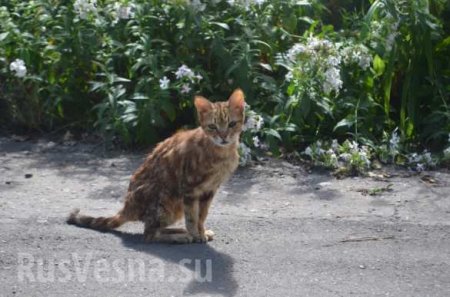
[108,230,238,297]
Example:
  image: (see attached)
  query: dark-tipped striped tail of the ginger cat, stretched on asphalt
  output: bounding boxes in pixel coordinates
[67,209,127,230]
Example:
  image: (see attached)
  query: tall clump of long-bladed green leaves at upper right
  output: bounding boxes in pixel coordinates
[364,0,449,142]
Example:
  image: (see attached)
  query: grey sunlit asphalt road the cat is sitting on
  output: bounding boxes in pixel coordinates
[0,138,450,297]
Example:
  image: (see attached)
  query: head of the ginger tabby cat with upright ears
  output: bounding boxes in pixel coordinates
[194,89,245,146]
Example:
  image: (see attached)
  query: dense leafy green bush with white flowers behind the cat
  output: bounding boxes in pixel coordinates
[0,0,450,171]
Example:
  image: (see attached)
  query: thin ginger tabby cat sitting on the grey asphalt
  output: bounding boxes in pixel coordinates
[67,89,245,243]
